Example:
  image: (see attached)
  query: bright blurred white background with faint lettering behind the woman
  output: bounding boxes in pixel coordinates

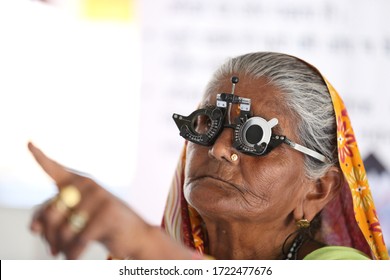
[0,0,390,259]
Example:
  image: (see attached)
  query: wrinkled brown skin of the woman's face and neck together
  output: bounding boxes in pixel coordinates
[185,76,322,259]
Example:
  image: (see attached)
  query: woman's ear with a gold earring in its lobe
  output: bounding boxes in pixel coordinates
[294,166,345,221]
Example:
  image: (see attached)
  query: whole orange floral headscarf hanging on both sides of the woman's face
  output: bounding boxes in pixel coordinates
[162,67,389,259]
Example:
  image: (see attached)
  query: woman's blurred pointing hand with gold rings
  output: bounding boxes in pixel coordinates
[28,143,154,259]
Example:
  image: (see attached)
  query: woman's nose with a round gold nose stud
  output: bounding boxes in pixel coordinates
[209,128,239,164]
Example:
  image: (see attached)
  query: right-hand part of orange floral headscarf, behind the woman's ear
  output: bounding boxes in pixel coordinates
[322,77,389,260]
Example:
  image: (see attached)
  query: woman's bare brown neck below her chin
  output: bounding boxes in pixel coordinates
[205,220,293,260]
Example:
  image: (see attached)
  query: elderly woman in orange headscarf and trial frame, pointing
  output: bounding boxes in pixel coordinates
[29,52,388,259]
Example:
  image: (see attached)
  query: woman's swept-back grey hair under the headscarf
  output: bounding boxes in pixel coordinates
[207,52,338,179]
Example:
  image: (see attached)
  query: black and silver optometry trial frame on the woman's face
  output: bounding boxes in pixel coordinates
[173,77,328,163]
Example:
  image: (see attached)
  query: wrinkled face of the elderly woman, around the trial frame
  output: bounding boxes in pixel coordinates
[184,76,308,222]
